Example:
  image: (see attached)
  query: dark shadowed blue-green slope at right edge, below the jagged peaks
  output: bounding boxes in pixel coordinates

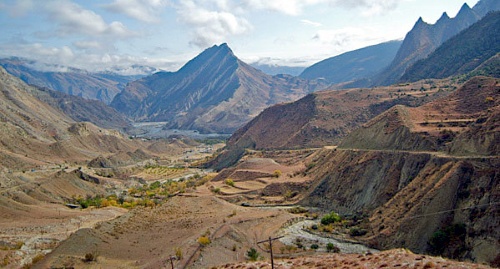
[401,11,500,81]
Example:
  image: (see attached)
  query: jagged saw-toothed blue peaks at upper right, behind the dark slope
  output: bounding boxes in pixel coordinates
[372,0,499,86]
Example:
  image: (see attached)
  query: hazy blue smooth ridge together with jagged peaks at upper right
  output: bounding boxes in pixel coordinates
[301,0,500,88]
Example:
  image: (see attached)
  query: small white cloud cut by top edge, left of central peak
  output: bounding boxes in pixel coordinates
[104,0,168,23]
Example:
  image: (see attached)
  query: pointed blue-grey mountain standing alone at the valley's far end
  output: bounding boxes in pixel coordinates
[111,44,322,133]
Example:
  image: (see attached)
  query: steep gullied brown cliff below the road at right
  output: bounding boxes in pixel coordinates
[301,149,500,263]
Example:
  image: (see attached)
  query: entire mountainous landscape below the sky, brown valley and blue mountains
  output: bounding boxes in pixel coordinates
[0,0,500,268]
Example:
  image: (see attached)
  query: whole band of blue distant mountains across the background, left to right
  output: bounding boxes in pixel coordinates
[0,0,498,136]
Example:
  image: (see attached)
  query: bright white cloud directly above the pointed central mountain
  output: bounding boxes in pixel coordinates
[177,0,252,48]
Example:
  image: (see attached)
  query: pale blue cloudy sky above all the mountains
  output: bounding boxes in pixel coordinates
[0,0,478,74]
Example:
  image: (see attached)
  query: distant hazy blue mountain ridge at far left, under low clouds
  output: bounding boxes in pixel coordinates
[0,58,154,104]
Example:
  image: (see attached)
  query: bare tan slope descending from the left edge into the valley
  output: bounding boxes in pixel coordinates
[0,68,142,169]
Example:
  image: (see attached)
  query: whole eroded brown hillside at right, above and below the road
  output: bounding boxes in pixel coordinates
[302,77,500,263]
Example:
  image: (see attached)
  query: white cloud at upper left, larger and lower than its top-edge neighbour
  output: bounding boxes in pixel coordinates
[44,0,134,38]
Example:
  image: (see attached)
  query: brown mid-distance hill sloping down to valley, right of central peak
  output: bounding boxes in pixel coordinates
[209,81,451,169]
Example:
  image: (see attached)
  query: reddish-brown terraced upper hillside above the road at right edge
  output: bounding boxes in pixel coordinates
[340,77,500,155]
